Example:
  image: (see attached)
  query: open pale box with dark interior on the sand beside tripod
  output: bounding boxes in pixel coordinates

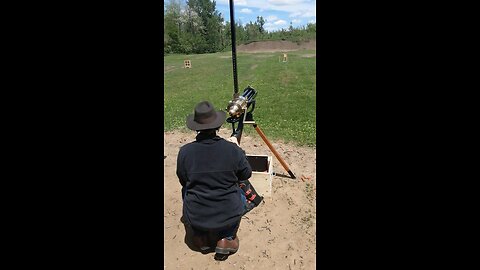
[247,155,273,197]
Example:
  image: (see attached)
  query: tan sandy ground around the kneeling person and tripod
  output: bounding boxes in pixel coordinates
[164,128,316,270]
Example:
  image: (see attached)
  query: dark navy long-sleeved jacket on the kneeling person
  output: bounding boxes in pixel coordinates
[177,133,252,230]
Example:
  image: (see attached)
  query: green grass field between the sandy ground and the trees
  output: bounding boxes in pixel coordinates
[164,50,316,146]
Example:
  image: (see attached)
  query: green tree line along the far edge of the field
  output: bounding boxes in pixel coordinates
[163,0,316,55]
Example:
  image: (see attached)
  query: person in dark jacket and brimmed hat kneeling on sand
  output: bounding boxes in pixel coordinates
[177,101,252,256]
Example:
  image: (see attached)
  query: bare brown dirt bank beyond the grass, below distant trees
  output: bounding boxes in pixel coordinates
[237,40,317,53]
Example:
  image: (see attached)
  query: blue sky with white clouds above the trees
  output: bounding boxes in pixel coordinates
[216,0,317,31]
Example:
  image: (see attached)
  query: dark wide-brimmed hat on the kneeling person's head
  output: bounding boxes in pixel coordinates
[187,101,227,131]
